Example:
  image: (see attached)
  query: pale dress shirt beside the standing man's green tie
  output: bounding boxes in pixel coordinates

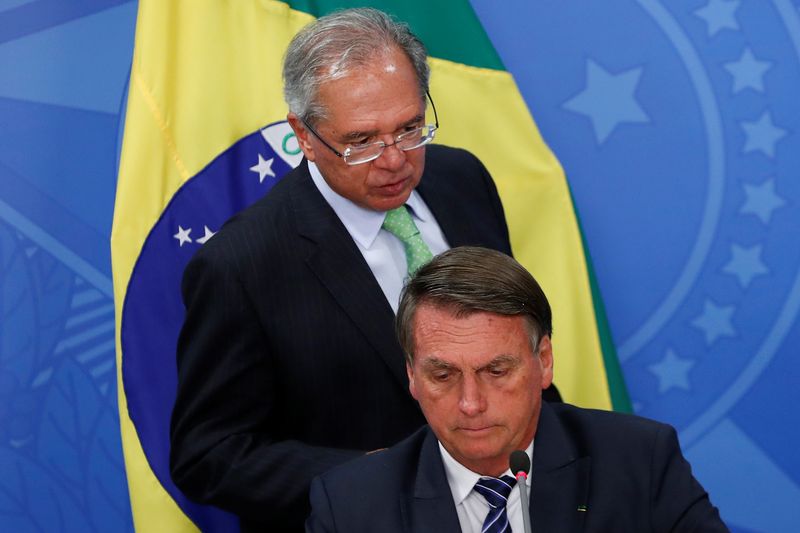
[308,161,450,313]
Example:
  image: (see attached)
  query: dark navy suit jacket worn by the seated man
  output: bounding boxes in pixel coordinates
[306,403,728,533]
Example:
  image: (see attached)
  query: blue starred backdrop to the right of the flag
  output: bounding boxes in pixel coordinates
[473,4,800,516]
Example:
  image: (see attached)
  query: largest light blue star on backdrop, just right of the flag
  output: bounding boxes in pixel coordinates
[563,59,650,144]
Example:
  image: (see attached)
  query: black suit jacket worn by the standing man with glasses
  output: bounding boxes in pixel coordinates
[170,146,511,531]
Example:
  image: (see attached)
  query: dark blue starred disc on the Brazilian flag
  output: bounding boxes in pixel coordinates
[121,121,302,531]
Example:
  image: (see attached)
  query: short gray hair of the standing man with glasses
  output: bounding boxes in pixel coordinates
[283,8,430,124]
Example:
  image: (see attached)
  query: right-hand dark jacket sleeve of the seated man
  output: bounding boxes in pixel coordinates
[650,425,728,533]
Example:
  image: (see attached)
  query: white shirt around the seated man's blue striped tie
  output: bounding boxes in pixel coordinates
[439,441,533,533]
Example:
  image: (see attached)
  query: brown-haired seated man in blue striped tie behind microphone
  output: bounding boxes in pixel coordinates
[307,247,727,533]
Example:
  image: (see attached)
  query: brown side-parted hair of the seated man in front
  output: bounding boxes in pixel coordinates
[395,246,553,364]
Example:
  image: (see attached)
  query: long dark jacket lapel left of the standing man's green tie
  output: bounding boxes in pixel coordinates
[290,160,408,389]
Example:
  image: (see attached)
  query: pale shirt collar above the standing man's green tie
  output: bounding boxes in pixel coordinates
[308,161,430,249]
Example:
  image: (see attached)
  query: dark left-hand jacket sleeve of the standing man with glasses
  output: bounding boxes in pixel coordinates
[170,250,361,529]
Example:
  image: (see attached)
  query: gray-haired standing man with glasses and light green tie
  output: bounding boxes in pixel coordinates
[171,9,544,531]
